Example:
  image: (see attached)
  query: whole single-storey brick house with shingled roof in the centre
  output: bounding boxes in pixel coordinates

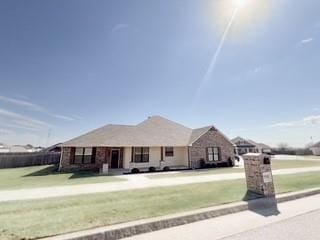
[59,116,235,172]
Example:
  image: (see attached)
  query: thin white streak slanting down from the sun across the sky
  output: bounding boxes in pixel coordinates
[193,8,239,105]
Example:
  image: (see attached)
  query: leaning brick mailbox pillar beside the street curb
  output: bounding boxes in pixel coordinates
[242,153,275,197]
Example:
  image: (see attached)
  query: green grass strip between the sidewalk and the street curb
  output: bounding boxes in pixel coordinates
[0,172,320,239]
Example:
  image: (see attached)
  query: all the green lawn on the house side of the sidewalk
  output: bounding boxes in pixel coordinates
[0,160,320,190]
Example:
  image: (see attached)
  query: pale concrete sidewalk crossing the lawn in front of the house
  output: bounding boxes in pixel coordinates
[0,167,320,202]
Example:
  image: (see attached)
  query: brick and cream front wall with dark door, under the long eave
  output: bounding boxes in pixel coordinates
[59,146,189,173]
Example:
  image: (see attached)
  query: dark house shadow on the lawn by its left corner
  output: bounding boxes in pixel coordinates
[23,165,101,179]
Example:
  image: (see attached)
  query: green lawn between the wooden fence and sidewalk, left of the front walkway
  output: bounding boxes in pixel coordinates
[0,165,124,190]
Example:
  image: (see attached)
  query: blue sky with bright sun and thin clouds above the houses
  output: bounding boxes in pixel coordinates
[0,0,320,146]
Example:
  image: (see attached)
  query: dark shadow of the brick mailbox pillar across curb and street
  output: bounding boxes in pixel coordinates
[242,191,280,217]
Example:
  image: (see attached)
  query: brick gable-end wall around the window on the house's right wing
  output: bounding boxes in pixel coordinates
[189,128,235,167]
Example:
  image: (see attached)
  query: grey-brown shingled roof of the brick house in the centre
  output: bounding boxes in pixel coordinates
[62,116,232,147]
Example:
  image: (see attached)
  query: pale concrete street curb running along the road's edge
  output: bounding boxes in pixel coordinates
[43,188,320,240]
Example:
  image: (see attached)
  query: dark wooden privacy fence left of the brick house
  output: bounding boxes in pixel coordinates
[0,152,60,168]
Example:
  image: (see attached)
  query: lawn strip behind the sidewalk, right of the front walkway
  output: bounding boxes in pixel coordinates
[148,160,320,179]
